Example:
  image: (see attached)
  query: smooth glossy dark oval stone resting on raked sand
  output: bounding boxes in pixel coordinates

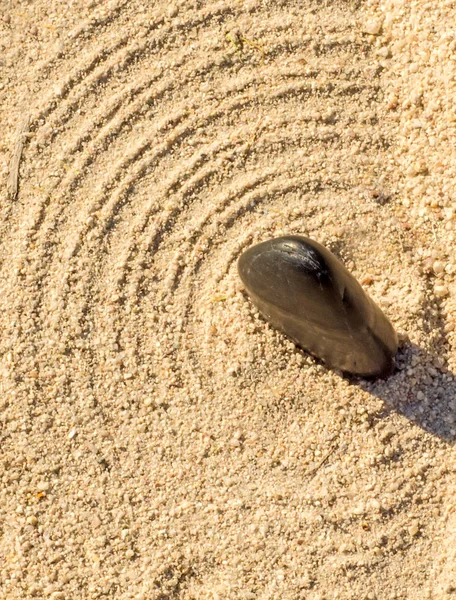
[238,235,398,377]
